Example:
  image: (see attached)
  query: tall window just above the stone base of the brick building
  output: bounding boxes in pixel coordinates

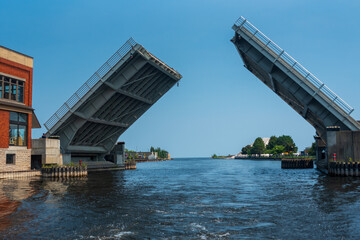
[9,112,28,146]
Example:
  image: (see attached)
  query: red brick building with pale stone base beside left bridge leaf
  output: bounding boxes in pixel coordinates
[0,46,40,172]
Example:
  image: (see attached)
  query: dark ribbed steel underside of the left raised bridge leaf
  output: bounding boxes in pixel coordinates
[52,49,181,154]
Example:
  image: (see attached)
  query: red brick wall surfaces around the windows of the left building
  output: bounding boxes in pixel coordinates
[0,57,33,148]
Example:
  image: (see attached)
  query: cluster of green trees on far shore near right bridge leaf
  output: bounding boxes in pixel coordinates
[241,135,298,155]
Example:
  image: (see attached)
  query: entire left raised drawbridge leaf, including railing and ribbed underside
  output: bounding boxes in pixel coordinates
[45,38,182,163]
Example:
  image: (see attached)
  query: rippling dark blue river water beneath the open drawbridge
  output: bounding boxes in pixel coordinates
[0,158,360,239]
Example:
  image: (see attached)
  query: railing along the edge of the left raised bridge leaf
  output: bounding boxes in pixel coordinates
[44,38,137,131]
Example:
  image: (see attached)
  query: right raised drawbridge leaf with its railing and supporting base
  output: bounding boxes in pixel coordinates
[231,17,360,171]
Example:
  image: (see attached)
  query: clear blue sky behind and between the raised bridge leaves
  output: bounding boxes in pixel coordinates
[0,0,360,157]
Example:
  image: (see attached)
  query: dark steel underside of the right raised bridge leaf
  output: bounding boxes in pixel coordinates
[232,31,359,141]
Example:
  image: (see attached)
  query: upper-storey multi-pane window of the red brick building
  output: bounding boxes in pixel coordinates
[0,75,25,103]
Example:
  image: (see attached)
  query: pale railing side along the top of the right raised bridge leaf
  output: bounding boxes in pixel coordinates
[235,17,354,115]
